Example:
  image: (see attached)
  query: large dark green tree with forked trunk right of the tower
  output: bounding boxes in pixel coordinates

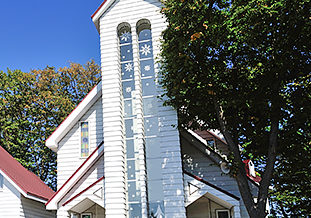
[160,0,311,218]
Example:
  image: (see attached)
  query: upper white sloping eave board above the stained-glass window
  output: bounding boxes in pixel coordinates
[45,82,102,152]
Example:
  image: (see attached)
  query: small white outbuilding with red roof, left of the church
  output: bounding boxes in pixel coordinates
[0,146,55,218]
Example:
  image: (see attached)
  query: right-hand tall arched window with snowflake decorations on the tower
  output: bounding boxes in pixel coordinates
[136,19,164,217]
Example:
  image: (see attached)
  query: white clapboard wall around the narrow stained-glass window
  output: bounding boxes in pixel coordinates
[57,98,103,189]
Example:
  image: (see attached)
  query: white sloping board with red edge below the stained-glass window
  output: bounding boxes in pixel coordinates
[46,145,104,210]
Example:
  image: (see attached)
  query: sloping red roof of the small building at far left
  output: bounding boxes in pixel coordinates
[0,146,54,200]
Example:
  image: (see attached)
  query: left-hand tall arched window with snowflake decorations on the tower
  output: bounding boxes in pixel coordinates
[118,23,141,217]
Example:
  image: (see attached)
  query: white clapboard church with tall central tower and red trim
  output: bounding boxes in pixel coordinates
[46,0,257,218]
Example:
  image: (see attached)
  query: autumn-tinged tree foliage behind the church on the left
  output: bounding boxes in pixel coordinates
[0,61,100,189]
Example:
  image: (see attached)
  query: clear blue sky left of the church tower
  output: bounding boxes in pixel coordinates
[0,0,103,72]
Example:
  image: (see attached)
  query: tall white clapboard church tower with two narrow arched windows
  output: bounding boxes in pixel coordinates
[92,0,186,218]
